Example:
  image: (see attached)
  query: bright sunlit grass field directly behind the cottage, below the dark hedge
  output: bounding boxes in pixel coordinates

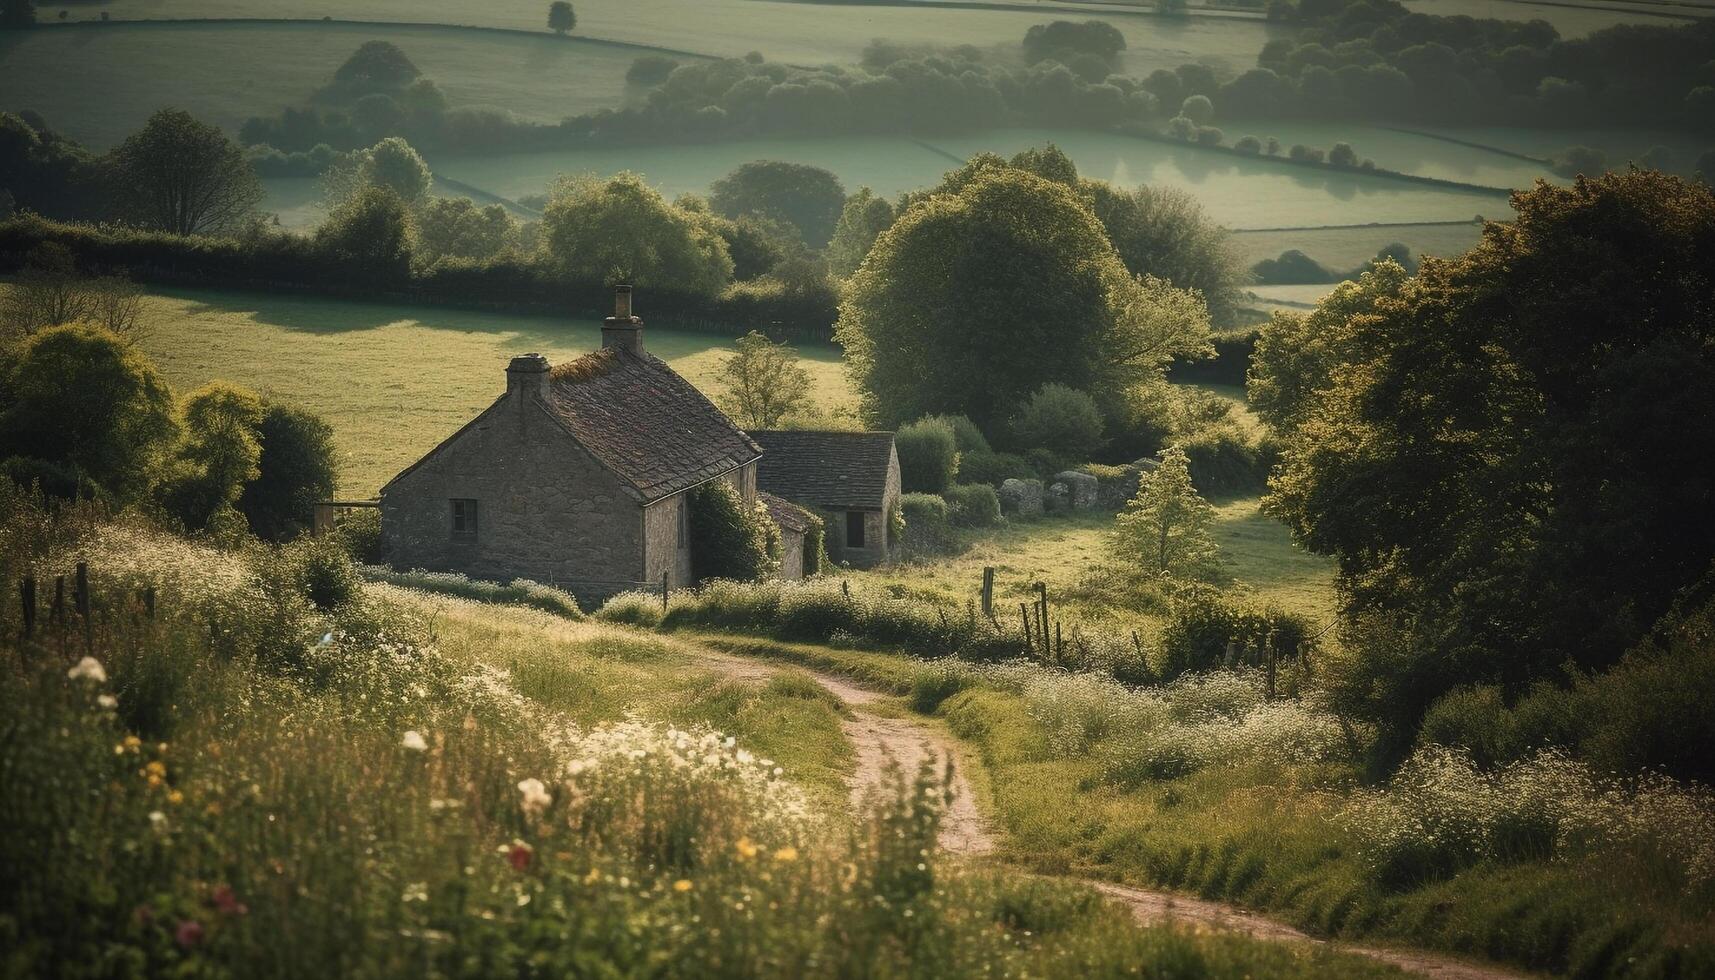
[124,290,854,496]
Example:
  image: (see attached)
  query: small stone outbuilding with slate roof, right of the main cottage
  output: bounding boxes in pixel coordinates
[749,429,900,568]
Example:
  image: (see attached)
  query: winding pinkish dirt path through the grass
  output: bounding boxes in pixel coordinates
[695,645,1525,980]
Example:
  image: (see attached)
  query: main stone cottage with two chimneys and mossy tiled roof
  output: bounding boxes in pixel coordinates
[381,287,768,601]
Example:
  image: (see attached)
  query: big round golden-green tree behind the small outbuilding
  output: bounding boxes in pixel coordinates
[837,168,1209,427]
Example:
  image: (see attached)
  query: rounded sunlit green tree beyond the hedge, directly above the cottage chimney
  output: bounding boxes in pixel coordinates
[542,173,732,295]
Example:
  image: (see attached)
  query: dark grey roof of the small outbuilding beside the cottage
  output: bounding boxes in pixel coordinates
[751,431,894,510]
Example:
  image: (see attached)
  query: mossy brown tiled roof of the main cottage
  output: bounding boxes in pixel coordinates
[547,347,761,501]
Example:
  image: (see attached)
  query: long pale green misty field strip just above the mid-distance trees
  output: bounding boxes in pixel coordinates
[430,129,1509,229]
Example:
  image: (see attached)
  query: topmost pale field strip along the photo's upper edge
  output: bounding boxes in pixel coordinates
[43,0,1290,74]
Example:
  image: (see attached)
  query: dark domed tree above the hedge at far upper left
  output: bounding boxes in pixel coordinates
[113,108,262,235]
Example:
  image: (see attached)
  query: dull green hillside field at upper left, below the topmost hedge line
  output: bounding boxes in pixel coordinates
[0,22,655,149]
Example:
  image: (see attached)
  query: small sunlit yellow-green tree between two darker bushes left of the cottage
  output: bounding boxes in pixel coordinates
[163,381,264,530]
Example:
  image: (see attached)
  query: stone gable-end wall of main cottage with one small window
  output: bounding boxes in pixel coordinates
[381,393,644,599]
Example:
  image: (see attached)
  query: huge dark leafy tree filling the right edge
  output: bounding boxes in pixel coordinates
[1267,170,1715,726]
